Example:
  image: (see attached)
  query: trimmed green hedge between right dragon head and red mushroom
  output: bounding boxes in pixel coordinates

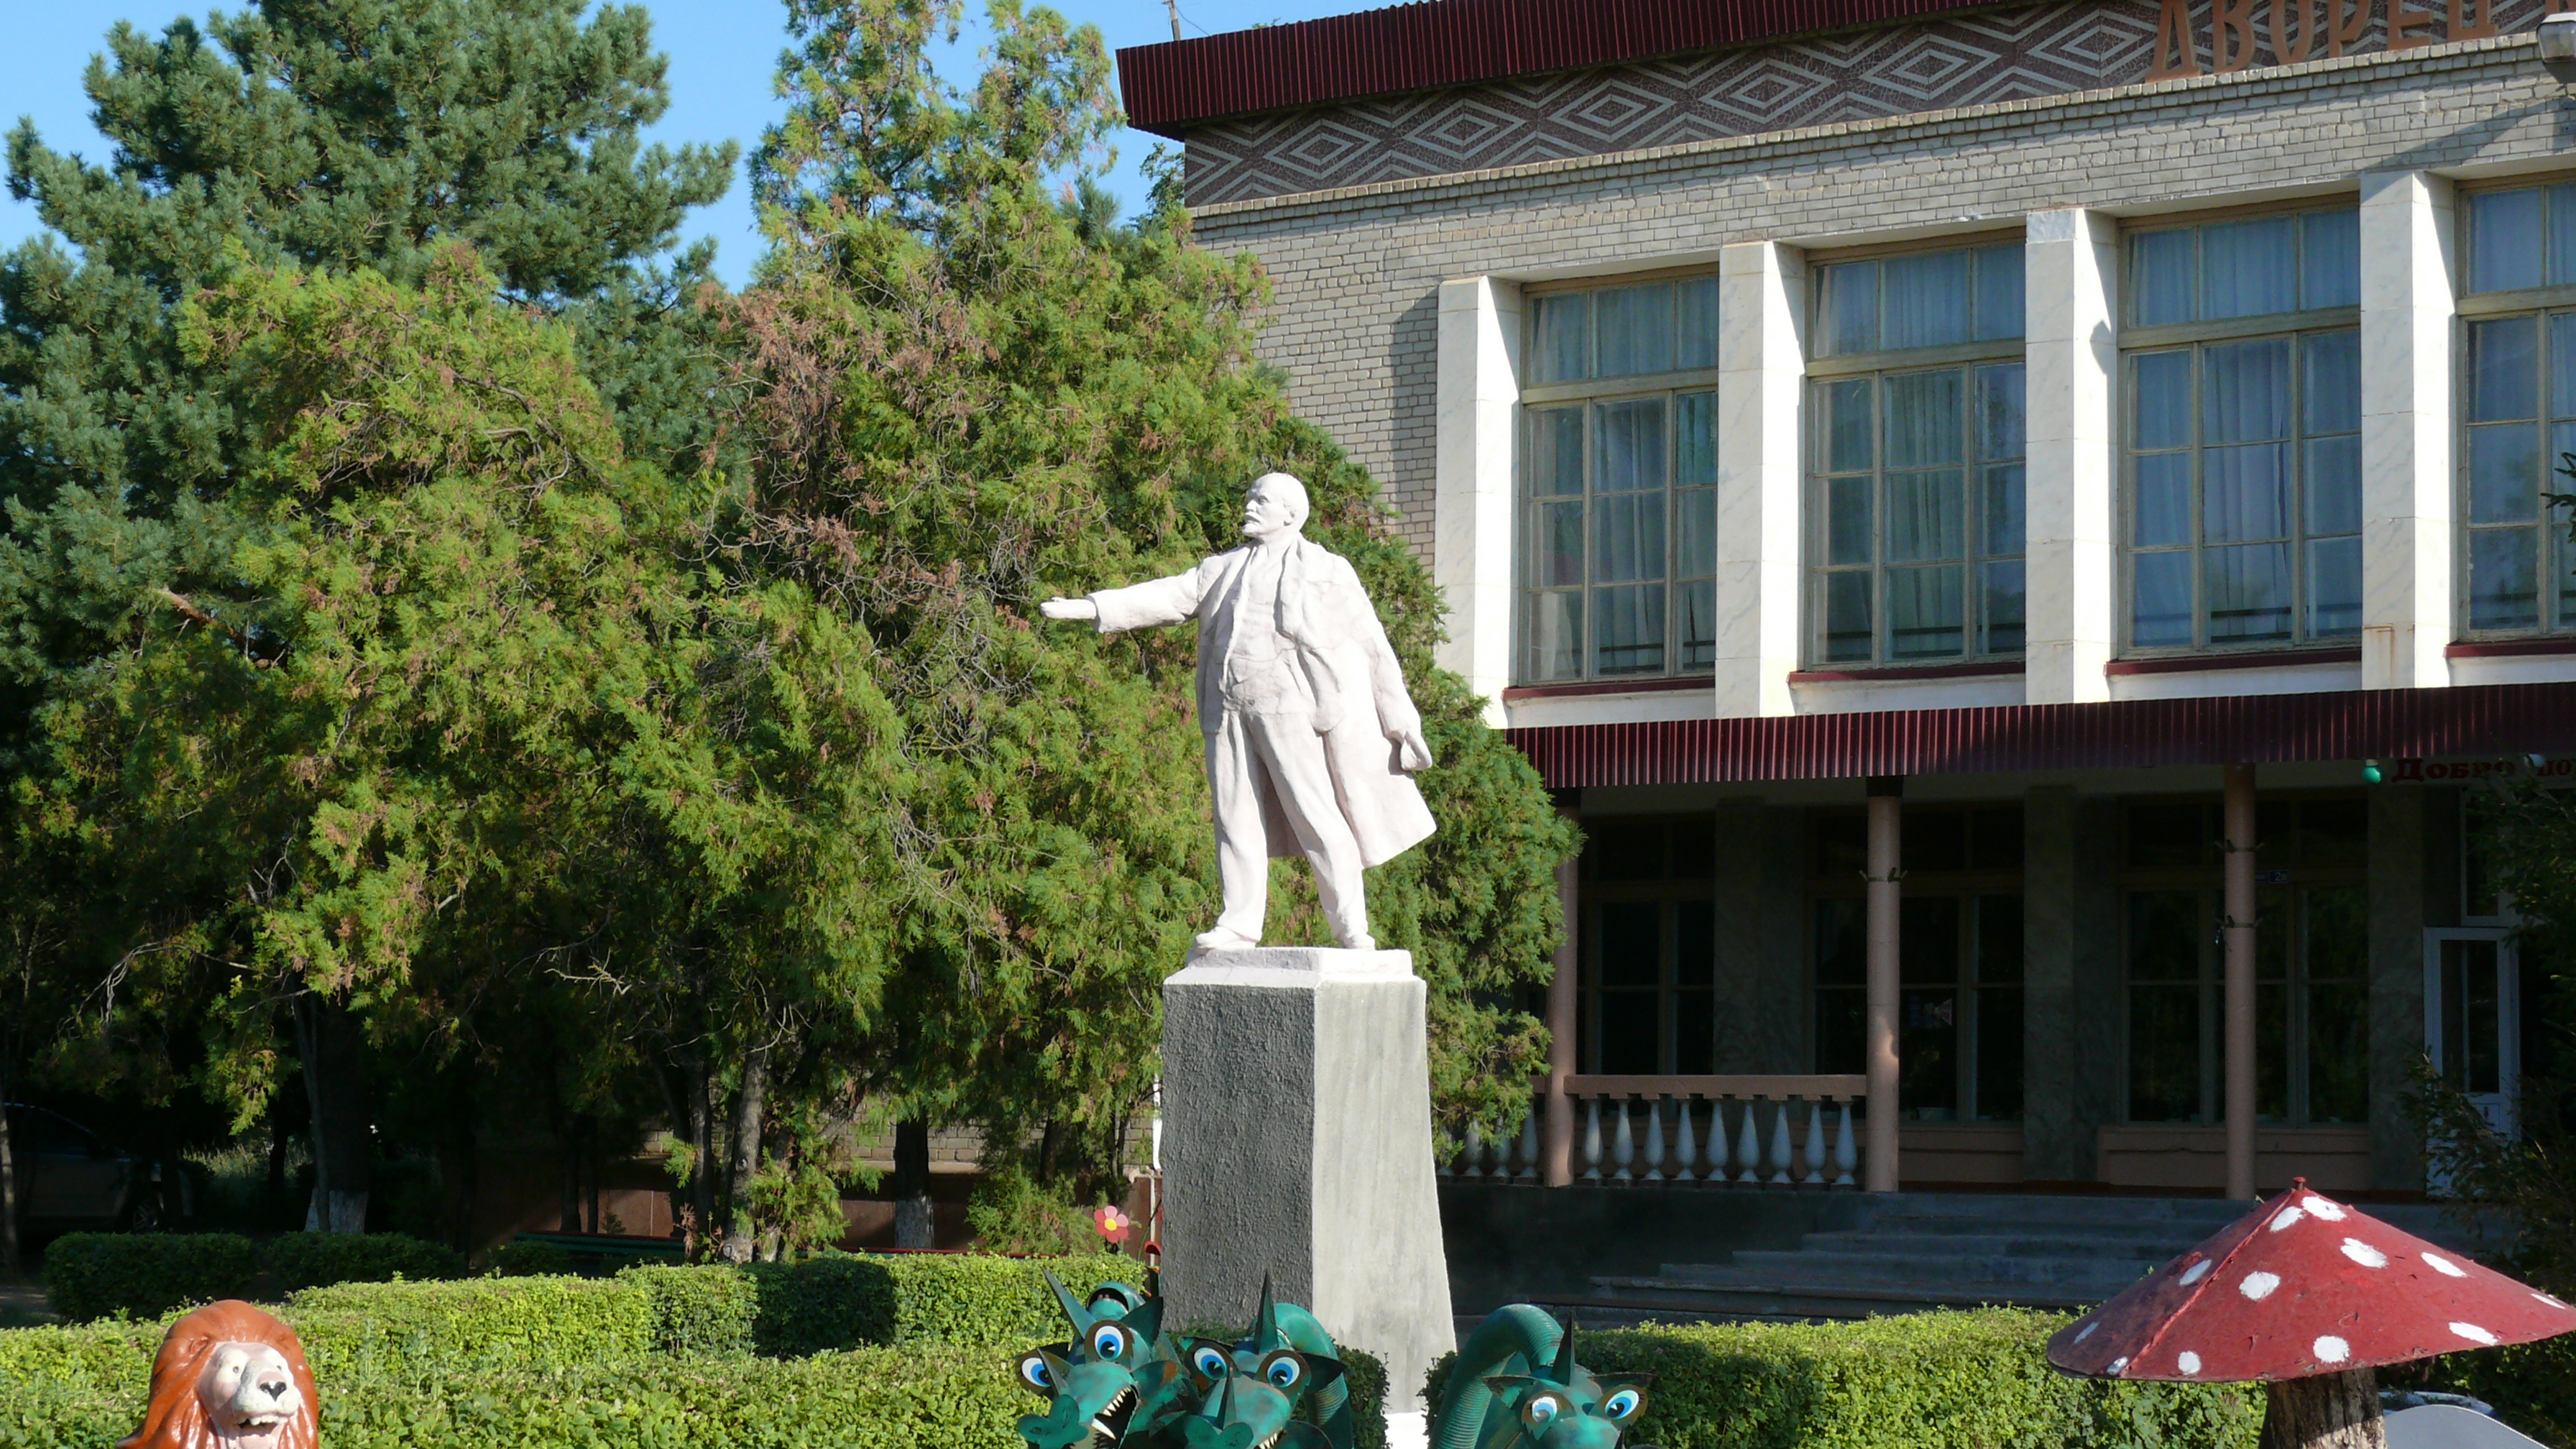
[1425,1310,2262,1449]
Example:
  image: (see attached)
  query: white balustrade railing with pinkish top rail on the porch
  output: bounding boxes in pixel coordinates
[1440,1075,1867,1189]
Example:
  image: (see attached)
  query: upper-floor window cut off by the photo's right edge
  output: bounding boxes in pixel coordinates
[2460,183,2576,634]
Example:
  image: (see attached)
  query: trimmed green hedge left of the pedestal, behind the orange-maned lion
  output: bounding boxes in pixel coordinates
[0,1253,1386,1449]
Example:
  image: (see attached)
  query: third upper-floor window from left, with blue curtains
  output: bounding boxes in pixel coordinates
[2122,209,2363,650]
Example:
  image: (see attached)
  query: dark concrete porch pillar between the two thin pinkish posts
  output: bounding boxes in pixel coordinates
[2022,786,2076,1184]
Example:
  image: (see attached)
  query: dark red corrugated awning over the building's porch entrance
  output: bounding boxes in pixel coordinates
[1509,684,2576,789]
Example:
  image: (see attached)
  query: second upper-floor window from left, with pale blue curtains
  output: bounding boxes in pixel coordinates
[1808,245,2025,665]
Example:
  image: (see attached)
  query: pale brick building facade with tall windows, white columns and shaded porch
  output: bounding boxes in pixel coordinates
[1121,0,2576,1194]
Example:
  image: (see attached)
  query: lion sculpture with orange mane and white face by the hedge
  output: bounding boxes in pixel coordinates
[116,1300,319,1449]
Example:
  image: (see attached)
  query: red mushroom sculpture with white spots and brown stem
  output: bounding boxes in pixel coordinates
[2048,1178,2576,1449]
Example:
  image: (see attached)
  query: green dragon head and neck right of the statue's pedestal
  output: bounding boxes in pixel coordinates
[1430,1302,1651,1449]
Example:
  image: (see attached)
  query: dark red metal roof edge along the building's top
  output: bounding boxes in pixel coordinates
[1118,0,2035,137]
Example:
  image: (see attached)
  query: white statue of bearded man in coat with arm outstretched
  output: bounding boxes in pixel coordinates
[1041,472,1435,952]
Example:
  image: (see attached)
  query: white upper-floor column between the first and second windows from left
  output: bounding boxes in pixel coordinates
[1716,242,1806,719]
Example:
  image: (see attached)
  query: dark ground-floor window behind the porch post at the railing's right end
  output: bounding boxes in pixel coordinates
[1811,804,2022,1121]
